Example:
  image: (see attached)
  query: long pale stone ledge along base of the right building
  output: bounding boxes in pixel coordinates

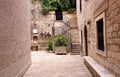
[84,56,115,77]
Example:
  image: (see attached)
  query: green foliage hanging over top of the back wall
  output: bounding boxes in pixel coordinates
[32,0,76,14]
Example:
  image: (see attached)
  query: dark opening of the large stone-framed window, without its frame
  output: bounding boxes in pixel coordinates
[96,18,104,51]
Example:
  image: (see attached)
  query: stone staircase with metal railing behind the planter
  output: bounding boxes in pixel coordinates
[52,16,80,55]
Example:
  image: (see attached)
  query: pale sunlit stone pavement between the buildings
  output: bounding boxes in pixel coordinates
[23,51,92,77]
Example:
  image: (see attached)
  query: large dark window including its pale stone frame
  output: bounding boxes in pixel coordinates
[95,12,107,57]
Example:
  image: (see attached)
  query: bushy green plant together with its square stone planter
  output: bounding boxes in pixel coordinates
[55,34,67,54]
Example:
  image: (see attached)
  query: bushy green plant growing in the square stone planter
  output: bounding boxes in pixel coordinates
[55,34,67,46]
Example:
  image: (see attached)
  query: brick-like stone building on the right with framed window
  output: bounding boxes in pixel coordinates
[77,0,120,77]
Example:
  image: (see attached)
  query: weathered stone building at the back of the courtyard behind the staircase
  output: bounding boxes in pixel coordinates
[31,1,79,50]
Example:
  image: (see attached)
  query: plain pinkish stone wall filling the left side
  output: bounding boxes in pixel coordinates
[0,0,31,77]
